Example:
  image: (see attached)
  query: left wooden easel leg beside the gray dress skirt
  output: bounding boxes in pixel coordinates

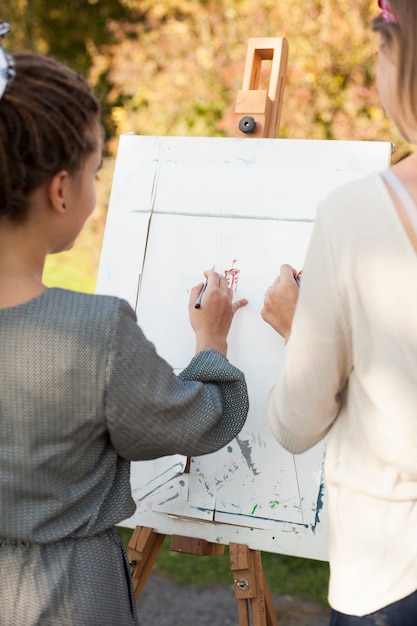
[127,526,165,601]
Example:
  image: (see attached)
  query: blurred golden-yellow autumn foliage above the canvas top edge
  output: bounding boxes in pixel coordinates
[99,0,408,156]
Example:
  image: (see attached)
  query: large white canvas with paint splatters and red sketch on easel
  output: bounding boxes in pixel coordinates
[97,135,390,559]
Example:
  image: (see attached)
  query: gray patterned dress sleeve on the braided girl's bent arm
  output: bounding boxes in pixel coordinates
[106,301,249,461]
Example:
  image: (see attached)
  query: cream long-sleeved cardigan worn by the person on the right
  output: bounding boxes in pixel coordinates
[268,173,417,615]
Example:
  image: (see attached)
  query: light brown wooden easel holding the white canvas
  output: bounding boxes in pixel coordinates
[128,37,288,626]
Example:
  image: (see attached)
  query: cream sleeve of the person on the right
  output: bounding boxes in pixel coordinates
[268,202,352,454]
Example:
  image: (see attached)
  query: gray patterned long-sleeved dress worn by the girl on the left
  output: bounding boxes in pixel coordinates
[0,289,248,626]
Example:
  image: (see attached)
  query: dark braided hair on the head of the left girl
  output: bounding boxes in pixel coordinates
[0,53,99,222]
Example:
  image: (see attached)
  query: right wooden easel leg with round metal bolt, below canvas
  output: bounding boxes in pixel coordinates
[229,543,278,626]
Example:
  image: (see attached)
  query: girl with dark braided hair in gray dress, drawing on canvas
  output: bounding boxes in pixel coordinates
[0,25,248,626]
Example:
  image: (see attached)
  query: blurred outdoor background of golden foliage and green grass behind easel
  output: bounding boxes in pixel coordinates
[0,0,411,605]
